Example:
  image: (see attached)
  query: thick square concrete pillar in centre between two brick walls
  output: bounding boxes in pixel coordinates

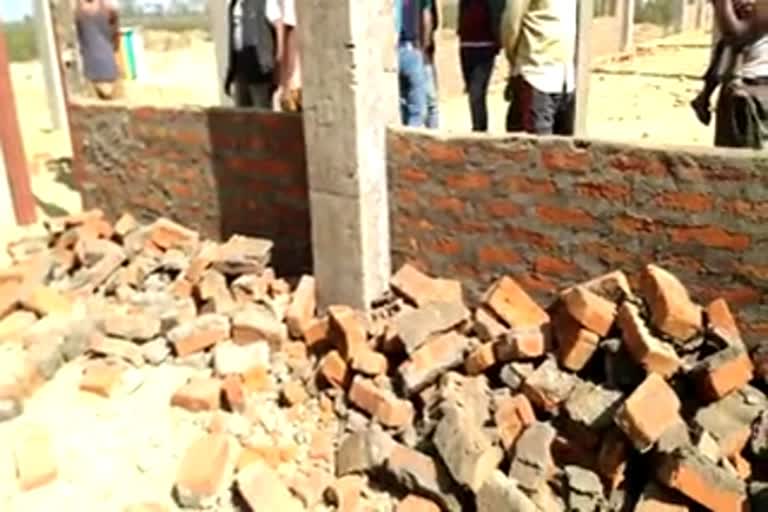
[296,0,398,308]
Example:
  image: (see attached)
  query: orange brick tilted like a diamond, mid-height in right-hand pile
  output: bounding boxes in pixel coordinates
[614,373,680,452]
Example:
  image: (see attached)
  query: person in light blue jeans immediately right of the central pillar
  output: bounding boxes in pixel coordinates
[395,0,432,127]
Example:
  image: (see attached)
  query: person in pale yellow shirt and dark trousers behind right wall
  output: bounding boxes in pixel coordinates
[502,0,579,135]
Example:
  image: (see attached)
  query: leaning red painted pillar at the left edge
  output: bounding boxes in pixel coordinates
[0,14,35,224]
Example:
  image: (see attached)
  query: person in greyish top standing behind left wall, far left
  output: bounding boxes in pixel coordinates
[75,0,120,100]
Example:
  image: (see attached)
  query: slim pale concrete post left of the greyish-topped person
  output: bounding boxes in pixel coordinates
[35,0,67,130]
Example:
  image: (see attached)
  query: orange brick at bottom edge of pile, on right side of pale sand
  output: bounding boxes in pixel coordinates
[176,434,232,508]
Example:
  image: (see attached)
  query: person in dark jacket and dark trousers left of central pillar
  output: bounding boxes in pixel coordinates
[224,0,279,110]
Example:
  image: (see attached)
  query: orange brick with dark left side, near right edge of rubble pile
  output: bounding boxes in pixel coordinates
[694,346,753,400]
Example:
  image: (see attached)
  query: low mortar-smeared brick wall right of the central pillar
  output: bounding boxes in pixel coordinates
[388,130,768,340]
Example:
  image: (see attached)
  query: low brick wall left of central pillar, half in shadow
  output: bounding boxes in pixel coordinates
[70,103,311,274]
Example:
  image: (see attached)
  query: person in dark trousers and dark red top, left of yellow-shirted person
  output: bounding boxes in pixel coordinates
[458,0,504,132]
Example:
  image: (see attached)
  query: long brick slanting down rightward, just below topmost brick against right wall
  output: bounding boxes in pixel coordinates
[617,302,682,377]
